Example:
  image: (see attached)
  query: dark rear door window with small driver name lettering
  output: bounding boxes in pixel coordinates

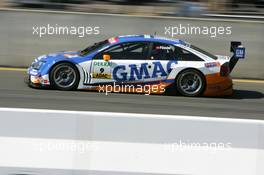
[150,43,176,60]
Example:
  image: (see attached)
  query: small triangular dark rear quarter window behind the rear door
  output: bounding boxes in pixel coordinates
[174,47,203,61]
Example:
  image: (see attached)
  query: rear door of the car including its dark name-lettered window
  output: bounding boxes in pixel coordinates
[146,42,177,82]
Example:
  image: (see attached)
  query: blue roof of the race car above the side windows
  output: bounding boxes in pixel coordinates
[115,35,186,45]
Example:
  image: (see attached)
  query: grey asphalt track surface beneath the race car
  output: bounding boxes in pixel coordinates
[0,70,264,120]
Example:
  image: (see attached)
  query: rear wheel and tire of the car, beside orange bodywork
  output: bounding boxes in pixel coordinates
[176,69,206,97]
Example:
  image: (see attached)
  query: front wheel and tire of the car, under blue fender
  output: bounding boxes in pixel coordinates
[49,62,80,91]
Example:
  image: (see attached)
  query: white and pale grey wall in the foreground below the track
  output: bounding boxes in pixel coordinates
[0,108,264,175]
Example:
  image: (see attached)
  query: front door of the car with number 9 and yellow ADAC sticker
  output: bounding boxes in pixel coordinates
[90,42,149,84]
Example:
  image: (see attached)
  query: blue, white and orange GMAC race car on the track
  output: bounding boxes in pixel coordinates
[28,35,245,96]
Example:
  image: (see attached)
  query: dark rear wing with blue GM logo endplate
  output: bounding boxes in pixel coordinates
[229,41,246,72]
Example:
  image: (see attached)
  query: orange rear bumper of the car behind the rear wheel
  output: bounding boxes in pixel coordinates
[204,73,233,96]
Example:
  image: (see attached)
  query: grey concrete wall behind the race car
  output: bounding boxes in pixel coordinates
[0,9,264,79]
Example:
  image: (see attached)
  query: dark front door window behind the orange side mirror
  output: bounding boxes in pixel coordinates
[95,42,148,60]
